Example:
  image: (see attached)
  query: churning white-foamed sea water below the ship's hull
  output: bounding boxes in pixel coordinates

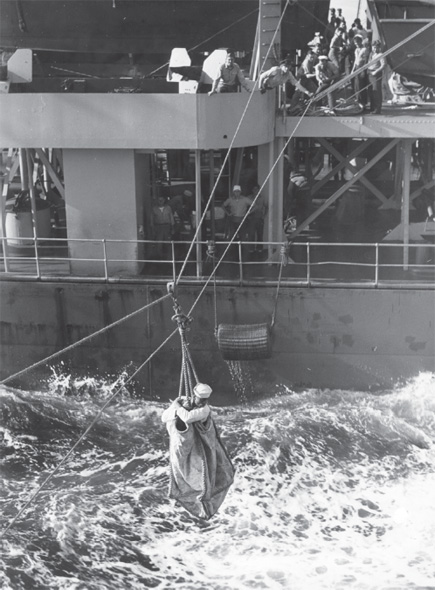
[0,373,435,590]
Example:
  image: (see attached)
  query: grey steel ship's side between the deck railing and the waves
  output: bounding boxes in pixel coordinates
[0,281,435,403]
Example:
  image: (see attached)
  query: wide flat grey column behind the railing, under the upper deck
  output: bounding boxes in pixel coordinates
[63,149,143,277]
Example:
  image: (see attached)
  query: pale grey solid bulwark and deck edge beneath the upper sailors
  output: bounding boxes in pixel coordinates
[0,91,435,149]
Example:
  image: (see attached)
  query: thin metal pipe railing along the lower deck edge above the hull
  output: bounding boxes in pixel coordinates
[0,237,435,289]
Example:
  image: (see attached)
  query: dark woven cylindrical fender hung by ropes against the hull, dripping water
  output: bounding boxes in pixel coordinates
[217,324,272,361]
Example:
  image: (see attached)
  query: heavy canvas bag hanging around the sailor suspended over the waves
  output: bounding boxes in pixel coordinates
[167,416,234,519]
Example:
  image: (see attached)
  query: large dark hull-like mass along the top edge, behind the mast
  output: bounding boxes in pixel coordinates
[0,0,329,88]
